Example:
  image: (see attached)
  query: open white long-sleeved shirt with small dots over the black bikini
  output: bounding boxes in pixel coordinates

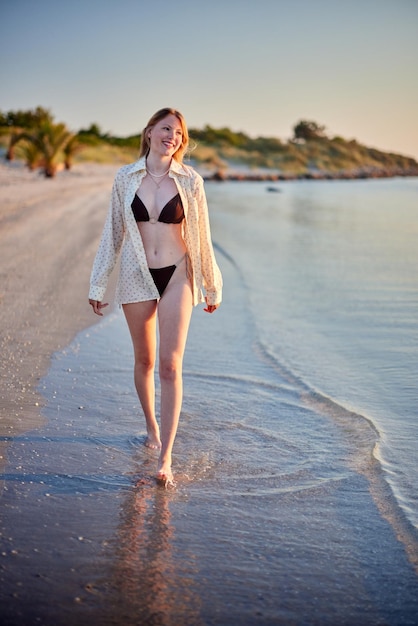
[89,157,222,305]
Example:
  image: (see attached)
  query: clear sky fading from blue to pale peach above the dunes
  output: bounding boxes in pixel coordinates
[0,0,418,158]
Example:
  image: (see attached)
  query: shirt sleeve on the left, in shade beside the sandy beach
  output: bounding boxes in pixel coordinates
[89,168,125,302]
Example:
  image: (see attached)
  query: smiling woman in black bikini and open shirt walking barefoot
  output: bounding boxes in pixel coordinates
[89,108,222,486]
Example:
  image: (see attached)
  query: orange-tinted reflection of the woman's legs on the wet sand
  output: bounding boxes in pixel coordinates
[103,463,202,626]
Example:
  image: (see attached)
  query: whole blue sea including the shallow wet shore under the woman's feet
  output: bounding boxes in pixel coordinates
[0,178,418,626]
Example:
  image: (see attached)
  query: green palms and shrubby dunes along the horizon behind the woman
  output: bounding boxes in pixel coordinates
[0,107,418,177]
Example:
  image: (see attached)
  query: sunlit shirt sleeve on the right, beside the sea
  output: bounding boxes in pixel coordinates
[195,175,222,305]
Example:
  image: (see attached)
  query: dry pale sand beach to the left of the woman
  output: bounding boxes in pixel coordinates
[0,160,117,448]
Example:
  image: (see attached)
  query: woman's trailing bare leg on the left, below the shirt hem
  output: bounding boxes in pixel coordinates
[123,300,161,449]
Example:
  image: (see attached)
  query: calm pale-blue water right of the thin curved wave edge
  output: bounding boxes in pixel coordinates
[209,179,418,527]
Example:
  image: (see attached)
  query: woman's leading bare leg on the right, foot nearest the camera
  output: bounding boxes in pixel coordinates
[157,266,192,482]
